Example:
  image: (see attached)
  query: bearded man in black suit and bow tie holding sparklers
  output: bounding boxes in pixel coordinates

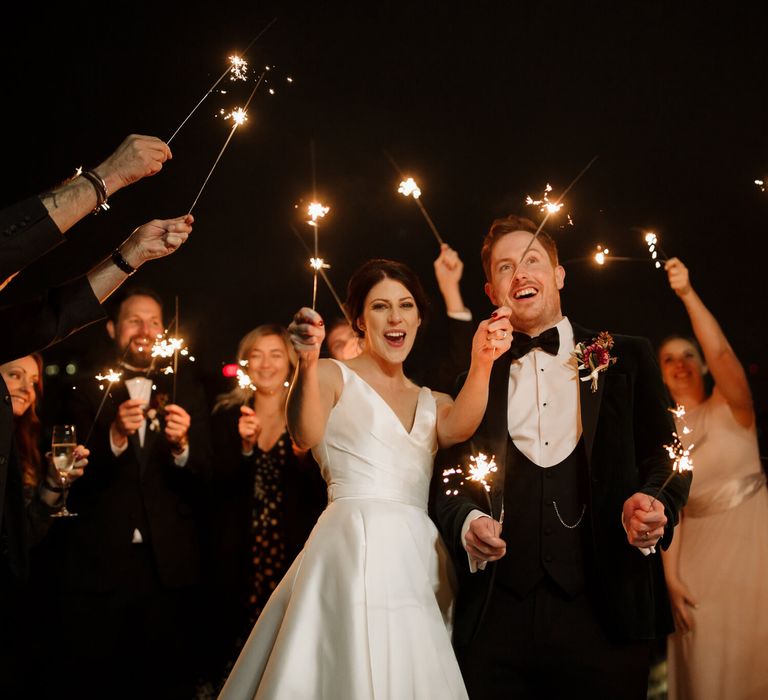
[50,288,210,698]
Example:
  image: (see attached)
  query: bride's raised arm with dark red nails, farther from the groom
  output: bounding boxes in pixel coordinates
[286,307,343,449]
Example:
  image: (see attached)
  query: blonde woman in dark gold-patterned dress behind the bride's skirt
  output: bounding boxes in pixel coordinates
[204,324,327,689]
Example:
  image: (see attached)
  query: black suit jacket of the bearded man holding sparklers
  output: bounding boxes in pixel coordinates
[49,366,211,591]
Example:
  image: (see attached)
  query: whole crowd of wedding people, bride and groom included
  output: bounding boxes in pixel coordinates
[0,135,768,700]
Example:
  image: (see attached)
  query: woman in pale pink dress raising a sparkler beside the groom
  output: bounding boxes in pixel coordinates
[659,258,768,700]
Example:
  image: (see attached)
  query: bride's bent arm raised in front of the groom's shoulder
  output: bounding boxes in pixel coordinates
[436,306,512,448]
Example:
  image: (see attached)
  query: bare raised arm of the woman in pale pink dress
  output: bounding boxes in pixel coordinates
[665,258,755,427]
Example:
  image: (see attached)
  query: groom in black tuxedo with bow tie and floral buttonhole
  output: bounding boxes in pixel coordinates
[434,216,690,700]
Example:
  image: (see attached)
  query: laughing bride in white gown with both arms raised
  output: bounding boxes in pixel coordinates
[220,260,512,700]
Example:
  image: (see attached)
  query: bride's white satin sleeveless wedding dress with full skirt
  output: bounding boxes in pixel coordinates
[220,363,467,700]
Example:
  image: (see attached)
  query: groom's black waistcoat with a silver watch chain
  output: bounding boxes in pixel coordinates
[496,438,590,596]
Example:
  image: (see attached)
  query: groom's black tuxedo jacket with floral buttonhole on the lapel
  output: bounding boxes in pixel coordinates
[432,325,690,648]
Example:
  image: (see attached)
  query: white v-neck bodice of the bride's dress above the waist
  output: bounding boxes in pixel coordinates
[313,362,437,508]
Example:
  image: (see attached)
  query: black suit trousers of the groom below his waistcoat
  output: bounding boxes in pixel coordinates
[457,579,652,700]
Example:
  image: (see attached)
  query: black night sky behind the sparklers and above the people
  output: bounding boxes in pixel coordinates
[0,1,768,442]
